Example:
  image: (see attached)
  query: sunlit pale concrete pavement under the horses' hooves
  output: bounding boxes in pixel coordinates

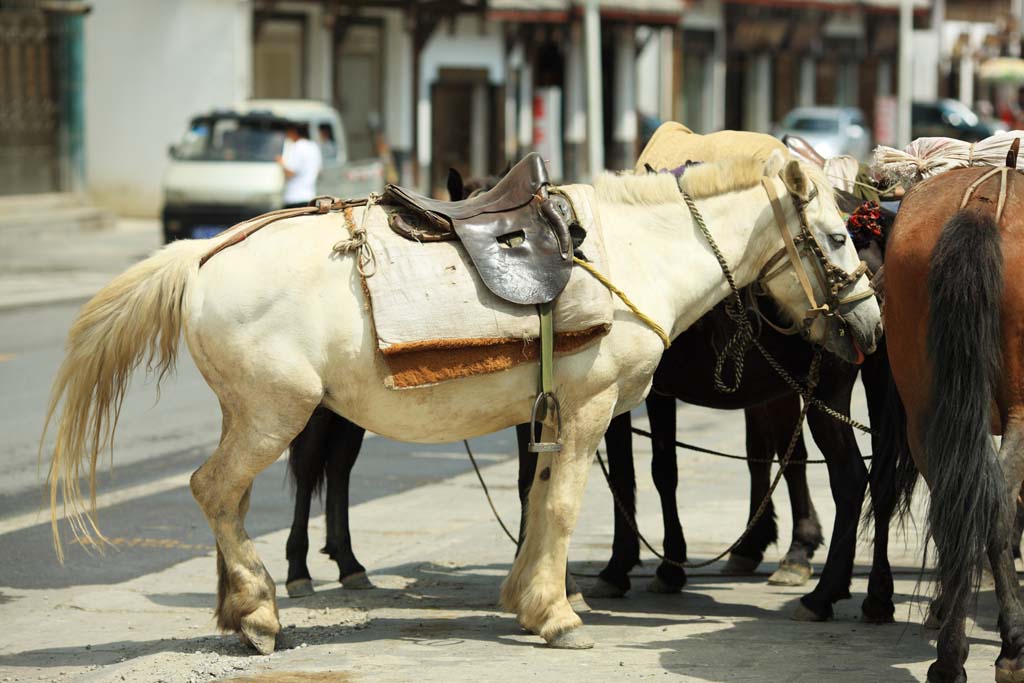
[0,385,998,683]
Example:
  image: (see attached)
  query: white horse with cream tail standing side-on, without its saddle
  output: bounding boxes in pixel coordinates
[47,155,881,653]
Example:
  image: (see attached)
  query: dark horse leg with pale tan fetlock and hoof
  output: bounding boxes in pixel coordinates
[768,394,824,586]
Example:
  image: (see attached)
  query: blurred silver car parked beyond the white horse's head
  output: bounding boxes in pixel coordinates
[775,106,871,160]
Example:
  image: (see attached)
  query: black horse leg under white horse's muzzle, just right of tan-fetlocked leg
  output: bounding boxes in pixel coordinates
[794,377,867,622]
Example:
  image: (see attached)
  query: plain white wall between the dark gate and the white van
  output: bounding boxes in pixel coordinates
[85,0,252,216]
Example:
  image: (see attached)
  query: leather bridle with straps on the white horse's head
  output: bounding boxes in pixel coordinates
[753,178,874,336]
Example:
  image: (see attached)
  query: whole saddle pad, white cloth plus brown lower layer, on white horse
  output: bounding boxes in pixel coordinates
[364,185,613,389]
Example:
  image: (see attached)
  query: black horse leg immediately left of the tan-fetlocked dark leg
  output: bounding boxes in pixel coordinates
[722,405,778,577]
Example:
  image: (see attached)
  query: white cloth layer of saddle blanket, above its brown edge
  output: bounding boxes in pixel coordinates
[365,185,612,355]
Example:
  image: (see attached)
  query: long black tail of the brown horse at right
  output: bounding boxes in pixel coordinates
[924,210,1009,621]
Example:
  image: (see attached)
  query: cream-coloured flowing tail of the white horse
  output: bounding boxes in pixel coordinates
[40,240,210,563]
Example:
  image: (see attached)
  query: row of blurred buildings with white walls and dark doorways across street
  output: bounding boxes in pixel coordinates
[6,0,991,215]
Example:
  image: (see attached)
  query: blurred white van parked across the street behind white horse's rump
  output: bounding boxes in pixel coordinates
[163,99,384,242]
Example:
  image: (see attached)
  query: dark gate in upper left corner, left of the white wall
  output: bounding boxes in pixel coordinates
[0,0,83,195]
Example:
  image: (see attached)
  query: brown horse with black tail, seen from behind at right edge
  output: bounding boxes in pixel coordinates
[885,168,1024,682]
